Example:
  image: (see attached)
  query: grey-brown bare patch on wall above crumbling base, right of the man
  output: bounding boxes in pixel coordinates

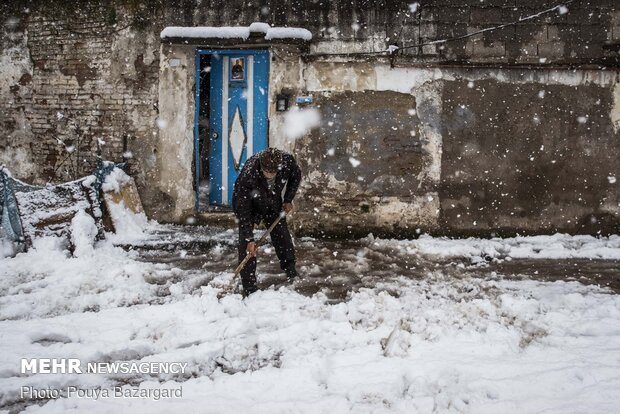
[297,91,425,196]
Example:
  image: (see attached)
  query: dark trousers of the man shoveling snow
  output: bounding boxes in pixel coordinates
[239,212,295,294]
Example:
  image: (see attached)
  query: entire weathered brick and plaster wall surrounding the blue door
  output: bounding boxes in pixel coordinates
[0,0,620,235]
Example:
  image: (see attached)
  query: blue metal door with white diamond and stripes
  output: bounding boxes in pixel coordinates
[199,50,269,206]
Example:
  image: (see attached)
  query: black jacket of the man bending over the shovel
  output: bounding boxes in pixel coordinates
[232,152,301,240]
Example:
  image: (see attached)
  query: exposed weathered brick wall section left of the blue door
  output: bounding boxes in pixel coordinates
[0,1,159,182]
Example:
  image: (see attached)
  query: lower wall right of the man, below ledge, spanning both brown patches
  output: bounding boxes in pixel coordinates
[297,63,620,235]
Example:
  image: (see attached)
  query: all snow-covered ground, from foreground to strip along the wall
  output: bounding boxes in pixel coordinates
[0,223,620,414]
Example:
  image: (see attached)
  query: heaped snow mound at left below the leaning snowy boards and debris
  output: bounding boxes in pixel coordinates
[0,236,163,320]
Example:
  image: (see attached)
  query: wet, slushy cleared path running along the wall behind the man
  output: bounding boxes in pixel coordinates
[117,226,620,302]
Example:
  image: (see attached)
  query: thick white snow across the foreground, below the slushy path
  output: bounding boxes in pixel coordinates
[0,273,620,413]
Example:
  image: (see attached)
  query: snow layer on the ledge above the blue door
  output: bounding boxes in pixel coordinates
[160,23,312,41]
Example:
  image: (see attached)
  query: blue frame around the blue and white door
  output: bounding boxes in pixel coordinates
[194,47,271,211]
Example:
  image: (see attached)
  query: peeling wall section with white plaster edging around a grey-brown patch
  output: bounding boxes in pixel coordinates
[293,62,442,236]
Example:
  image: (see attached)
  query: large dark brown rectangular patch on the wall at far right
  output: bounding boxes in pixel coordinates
[439,80,620,233]
